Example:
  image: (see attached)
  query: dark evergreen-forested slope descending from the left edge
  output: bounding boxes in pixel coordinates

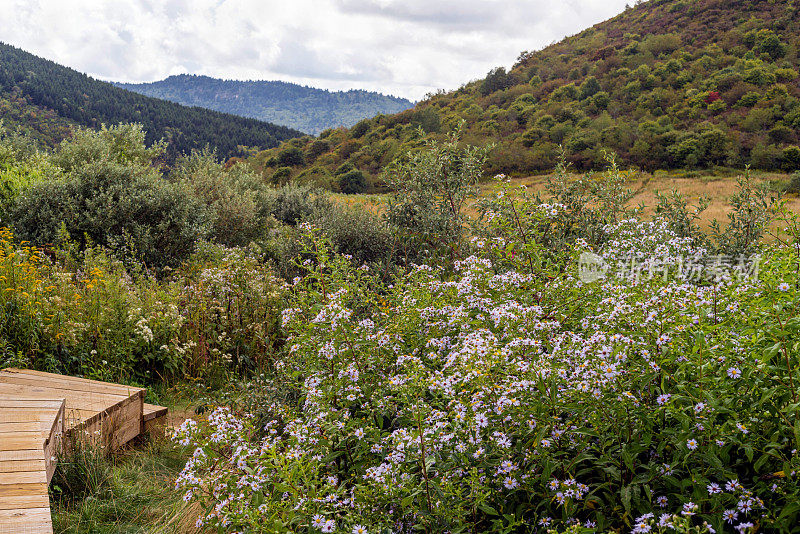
[0,43,302,157]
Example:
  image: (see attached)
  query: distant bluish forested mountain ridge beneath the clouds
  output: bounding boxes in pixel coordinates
[115,74,413,135]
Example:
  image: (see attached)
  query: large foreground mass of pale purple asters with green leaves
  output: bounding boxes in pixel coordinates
[176,204,800,533]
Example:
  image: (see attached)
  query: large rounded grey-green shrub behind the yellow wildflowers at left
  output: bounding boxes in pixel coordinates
[13,161,208,269]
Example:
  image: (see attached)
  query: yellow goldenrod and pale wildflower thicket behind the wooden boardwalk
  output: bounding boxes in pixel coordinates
[0,229,283,383]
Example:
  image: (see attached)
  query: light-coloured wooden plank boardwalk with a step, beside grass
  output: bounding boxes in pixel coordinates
[0,369,167,534]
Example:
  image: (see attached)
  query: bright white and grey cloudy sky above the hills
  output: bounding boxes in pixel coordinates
[0,0,630,100]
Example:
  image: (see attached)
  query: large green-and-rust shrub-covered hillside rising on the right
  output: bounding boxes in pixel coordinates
[256,0,800,192]
